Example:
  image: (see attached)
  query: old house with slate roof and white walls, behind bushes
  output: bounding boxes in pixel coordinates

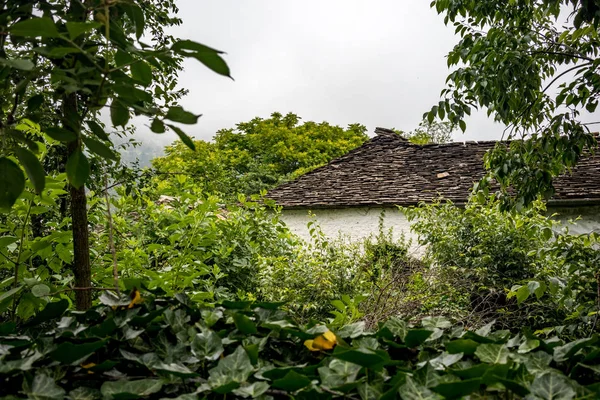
[268,128,600,247]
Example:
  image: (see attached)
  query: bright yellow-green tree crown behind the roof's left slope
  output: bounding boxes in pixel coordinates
[153,113,368,196]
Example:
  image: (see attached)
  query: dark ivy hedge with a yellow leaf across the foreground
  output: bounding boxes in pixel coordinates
[0,291,600,400]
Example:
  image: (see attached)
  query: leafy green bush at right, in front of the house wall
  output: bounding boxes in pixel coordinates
[405,196,600,337]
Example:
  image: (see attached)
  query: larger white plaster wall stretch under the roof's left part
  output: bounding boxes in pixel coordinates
[282,207,422,254]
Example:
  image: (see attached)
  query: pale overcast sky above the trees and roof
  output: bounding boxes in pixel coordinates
[140,0,502,145]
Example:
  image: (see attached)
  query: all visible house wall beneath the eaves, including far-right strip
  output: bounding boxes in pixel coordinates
[282,207,600,255]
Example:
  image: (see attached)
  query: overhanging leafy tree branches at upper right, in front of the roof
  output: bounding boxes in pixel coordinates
[426,0,600,205]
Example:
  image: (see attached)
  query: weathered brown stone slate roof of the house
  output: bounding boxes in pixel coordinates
[267,128,600,208]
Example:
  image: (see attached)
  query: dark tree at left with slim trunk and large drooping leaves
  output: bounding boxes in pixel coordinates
[0,0,229,309]
